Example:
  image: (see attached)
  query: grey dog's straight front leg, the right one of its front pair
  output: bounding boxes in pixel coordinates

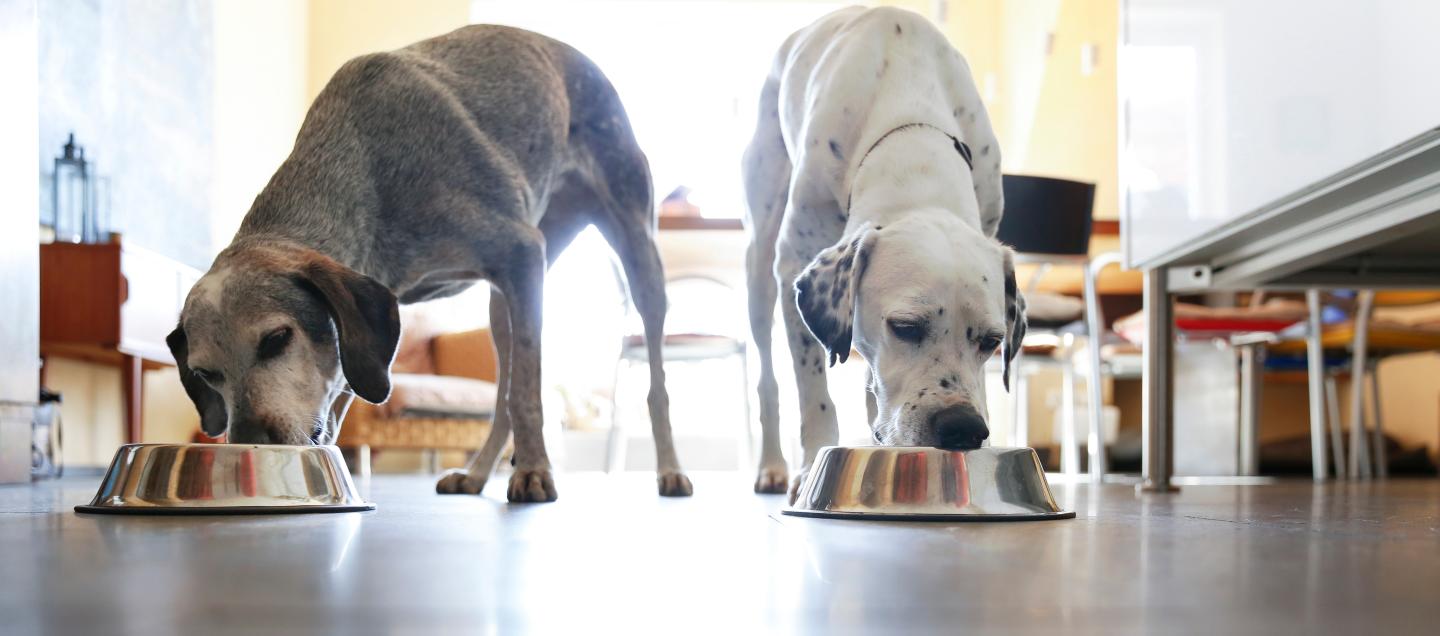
[495,232,556,502]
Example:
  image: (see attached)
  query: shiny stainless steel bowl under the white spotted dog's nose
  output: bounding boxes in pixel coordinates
[782,446,1076,521]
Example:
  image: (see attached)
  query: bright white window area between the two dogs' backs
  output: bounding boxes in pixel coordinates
[471,0,844,219]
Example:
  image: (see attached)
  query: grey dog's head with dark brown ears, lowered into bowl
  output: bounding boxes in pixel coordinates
[167,246,400,445]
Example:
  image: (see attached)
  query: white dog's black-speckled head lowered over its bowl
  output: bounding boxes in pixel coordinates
[795,214,1025,448]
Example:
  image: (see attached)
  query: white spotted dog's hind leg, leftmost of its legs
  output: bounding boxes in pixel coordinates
[743,71,791,492]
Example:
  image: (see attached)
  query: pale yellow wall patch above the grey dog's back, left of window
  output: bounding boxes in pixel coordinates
[305,0,469,104]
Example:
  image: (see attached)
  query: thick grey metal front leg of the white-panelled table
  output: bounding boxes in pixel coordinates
[1136,269,1178,492]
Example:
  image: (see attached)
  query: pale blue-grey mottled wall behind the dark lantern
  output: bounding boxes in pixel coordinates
[39,0,215,269]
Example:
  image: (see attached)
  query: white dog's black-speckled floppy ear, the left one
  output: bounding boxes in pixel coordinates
[795,226,880,367]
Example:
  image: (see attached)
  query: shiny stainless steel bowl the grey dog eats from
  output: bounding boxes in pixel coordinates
[75,443,374,515]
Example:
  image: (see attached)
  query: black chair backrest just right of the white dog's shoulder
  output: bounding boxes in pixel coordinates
[996,174,1094,255]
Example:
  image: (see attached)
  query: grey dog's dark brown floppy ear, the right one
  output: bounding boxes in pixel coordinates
[298,255,400,404]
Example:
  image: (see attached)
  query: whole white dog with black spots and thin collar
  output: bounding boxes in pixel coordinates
[744,7,1025,498]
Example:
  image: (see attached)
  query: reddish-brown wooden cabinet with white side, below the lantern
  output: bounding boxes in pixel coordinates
[40,242,200,443]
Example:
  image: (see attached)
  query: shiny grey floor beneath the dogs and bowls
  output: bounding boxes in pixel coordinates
[0,473,1440,635]
